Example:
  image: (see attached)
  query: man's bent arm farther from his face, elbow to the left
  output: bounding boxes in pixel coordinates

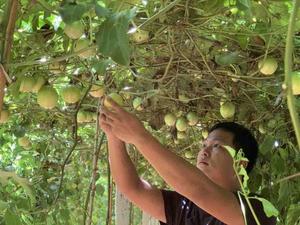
[100,116,166,222]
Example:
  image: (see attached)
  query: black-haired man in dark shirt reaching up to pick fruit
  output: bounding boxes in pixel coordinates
[99,99,275,225]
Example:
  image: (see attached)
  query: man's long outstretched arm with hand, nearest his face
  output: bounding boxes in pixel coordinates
[103,100,244,225]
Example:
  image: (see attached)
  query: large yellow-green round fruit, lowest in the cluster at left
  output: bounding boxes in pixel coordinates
[37,86,58,109]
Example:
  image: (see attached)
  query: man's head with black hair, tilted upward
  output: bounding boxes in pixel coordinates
[197,122,258,189]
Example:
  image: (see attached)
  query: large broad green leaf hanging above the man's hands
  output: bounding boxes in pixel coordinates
[96,10,137,65]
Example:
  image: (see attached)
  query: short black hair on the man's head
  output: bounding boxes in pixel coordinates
[209,122,258,173]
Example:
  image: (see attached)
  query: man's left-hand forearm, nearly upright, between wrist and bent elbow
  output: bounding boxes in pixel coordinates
[108,137,140,192]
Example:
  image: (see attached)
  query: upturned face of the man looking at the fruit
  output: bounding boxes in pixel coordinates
[197,129,235,186]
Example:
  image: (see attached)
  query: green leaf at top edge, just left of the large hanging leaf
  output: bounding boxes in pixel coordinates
[58,3,89,23]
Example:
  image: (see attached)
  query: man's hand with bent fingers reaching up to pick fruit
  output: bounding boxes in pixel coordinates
[99,98,148,144]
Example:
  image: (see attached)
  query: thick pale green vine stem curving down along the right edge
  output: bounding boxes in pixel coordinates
[284,0,300,147]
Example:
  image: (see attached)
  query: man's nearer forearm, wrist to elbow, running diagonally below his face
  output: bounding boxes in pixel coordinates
[134,132,212,197]
